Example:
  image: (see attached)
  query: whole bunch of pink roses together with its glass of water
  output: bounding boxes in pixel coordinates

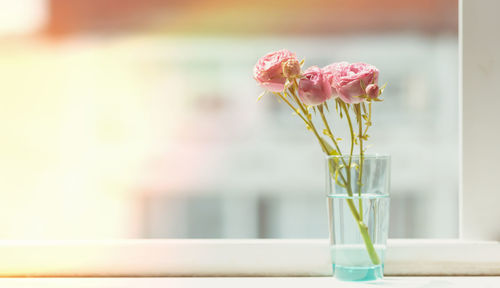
[253,50,390,281]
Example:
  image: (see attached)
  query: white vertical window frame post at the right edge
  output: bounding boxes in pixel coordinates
[459,0,500,240]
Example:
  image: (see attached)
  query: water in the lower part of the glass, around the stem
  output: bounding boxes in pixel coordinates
[327,194,389,281]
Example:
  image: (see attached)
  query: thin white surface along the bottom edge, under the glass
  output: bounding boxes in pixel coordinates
[0,277,500,288]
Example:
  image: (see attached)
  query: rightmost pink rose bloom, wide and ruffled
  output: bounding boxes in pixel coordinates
[323,62,379,104]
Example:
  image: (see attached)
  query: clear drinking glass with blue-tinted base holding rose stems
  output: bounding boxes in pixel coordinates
[326,154,390,281]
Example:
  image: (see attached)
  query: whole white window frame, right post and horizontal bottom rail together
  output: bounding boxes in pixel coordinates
[0,0,500,277]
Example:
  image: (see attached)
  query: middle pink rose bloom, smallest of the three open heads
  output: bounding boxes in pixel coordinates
[299,66,332,106]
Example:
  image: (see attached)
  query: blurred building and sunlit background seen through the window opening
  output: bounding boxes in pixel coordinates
[0,0,459,239]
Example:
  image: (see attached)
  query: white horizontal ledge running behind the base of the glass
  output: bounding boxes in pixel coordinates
[0,239,500,277]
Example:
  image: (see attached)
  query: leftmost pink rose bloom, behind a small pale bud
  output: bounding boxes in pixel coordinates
[253,50,297,92]
